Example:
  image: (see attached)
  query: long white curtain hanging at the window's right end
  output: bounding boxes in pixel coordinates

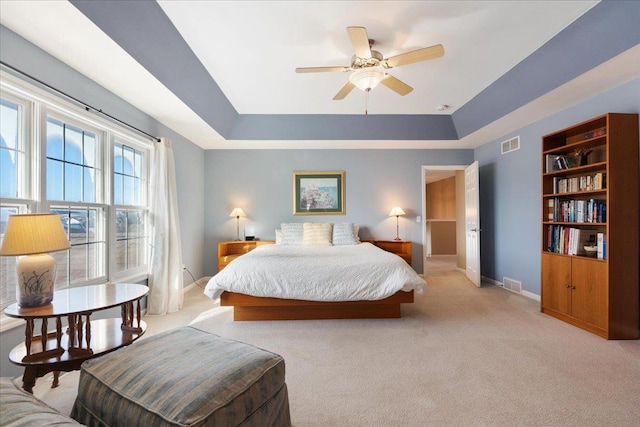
[147,138,183,314]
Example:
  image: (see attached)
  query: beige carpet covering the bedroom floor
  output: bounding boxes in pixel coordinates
[35,263,640,427]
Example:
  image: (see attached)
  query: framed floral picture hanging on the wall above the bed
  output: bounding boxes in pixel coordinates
[293,171,345,215]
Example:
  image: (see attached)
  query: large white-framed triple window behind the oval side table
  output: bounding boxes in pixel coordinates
[0,73,152,309]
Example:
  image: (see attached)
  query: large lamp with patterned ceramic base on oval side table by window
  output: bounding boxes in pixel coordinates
[0,213,70,308]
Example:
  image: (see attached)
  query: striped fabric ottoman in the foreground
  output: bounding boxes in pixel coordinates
[71,327,291,427]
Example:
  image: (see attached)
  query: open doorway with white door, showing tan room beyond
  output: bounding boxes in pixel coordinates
[422,162,480,286]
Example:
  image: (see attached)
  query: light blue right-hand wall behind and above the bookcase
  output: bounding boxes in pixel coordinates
[475,79,640,295]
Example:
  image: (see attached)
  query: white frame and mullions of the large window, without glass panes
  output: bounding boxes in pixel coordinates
[0,70,155,332]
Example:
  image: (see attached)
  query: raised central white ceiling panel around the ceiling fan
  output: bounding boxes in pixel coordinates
[159,0,597,114]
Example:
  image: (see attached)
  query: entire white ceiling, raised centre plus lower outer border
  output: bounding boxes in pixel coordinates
[0,0,640,148]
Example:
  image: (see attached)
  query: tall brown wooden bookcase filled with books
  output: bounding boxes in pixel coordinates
[541,113,640,339]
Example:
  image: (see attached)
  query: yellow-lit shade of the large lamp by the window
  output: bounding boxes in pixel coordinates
[0,213,69,256]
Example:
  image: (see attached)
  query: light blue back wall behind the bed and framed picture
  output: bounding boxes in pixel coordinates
[205,149,473,276]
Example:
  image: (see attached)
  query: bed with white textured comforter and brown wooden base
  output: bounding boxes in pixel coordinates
[204,223,425,320]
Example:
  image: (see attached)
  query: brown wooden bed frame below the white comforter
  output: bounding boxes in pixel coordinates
[220,290,413,320]
